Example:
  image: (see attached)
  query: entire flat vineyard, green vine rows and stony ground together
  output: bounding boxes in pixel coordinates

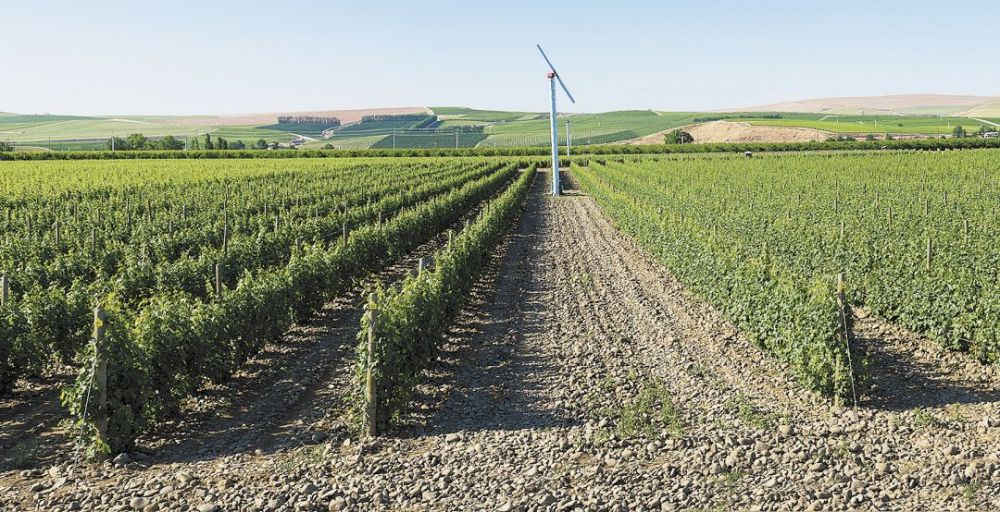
[0,150,1000,511]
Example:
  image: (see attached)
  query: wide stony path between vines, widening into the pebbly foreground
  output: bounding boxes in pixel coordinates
[0,170,1000,510]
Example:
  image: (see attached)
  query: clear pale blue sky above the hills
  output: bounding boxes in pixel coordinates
[0,0,1000,114]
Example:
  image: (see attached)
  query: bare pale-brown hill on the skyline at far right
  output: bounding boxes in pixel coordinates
[724,94,1000,116]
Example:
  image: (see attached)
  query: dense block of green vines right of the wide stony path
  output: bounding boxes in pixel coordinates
[578,152,1000,399]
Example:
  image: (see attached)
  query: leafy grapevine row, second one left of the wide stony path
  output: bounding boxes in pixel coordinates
[64,159,528,452]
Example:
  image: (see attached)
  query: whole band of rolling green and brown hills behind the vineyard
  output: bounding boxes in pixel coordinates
[0,94,1000,150]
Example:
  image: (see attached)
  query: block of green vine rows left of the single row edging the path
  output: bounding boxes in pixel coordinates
[0,161,540,453]
